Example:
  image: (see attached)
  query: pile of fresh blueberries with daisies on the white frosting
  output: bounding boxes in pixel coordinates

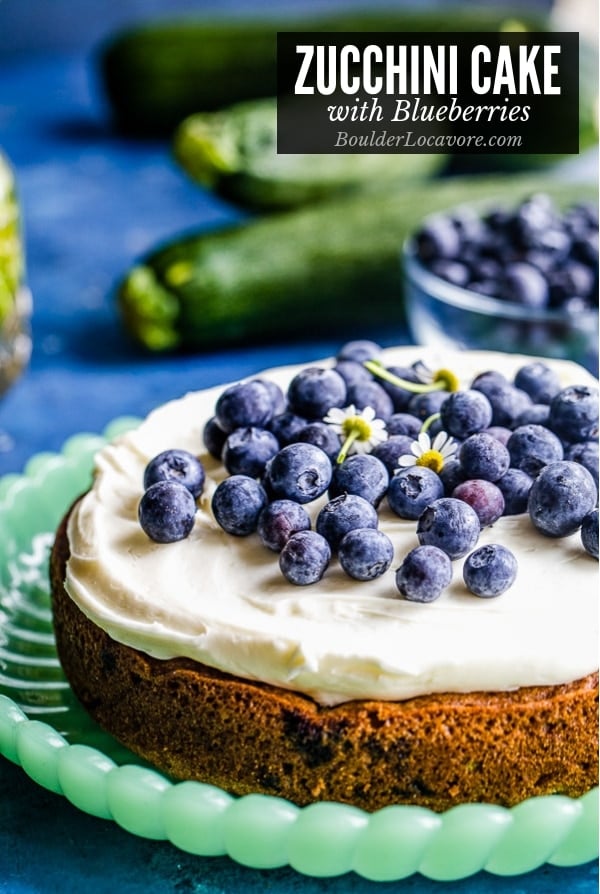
[139,341,598,602]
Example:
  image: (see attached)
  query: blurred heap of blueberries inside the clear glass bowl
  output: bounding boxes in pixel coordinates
[415,194,598,314]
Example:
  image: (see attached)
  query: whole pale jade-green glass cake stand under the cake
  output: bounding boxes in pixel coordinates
[0,418,598,881]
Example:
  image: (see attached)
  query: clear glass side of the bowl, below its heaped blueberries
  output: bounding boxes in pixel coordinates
[402,239,598,375]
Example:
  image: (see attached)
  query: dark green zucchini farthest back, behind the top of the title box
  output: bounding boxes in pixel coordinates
[98,4,547,136]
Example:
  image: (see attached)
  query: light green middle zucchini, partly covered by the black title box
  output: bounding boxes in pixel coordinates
[173,98,445,211]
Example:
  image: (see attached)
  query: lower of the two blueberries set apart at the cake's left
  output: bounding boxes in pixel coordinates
[138,479,196,543]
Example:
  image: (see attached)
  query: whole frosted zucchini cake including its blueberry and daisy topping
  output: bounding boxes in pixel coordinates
[51,345,598,811]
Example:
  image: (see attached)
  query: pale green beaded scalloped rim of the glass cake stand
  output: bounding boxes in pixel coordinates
[0,417,598,881]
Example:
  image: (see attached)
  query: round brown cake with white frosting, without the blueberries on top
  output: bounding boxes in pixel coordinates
[51,347,598,811]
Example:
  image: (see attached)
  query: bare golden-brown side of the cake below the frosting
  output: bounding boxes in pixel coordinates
[50,504,598,811]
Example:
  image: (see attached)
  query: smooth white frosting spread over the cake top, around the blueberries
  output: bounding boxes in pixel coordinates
[66,348,598,704]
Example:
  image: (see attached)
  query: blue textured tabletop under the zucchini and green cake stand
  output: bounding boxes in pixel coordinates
[0,24,598,894]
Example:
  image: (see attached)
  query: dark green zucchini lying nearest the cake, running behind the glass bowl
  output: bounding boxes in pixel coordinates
[118,177,595,351]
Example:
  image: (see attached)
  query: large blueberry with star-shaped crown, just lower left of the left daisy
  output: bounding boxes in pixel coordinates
[265,443,332,503]
